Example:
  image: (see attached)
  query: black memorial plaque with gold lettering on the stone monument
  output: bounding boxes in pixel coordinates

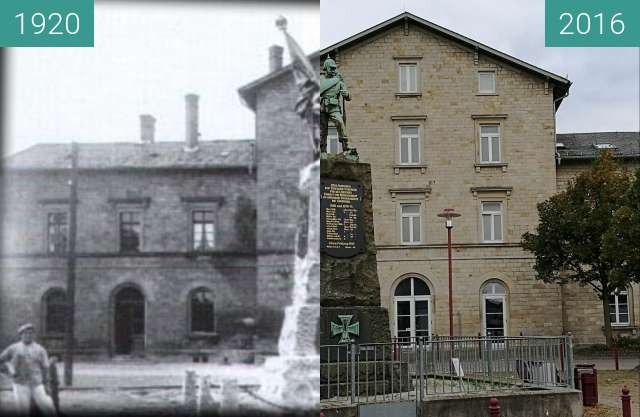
[320,179,364,258]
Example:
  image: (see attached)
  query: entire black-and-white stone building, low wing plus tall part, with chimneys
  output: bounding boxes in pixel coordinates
[0,42,318,361]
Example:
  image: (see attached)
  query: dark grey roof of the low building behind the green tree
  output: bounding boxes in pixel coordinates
[556,132,640,160]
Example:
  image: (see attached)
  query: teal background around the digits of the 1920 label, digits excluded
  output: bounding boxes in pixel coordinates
[0,0,93,47]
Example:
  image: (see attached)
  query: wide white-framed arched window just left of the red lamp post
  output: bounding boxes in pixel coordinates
[393,277,431,341]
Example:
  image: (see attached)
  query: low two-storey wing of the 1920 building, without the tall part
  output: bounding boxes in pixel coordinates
[0,108,256,355]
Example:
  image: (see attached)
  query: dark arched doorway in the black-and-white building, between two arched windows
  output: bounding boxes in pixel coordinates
[113,287,145,355]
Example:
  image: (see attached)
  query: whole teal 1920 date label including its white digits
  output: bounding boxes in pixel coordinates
[0,0,94,47]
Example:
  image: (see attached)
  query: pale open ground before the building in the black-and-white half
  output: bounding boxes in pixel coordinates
[0,361,284,417]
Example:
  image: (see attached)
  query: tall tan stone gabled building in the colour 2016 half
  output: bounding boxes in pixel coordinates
[321,13,640,343]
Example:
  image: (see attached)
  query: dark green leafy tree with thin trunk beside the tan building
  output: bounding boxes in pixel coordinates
[522,152,640,346]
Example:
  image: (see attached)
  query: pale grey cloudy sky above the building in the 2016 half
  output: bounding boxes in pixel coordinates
[320,0,640,133]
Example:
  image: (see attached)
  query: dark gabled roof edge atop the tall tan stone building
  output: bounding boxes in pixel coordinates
[320,12,571,106]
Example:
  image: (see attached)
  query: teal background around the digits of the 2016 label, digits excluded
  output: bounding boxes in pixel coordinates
[544,0,640,46]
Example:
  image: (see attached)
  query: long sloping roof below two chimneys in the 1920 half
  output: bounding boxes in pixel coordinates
[3,139,255,170]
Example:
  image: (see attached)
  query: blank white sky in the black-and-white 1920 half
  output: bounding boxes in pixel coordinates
[3,1,320,155]
